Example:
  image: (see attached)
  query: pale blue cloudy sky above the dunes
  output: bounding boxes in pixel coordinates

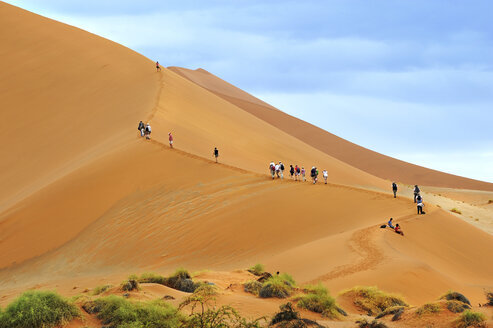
[7,0,493,182]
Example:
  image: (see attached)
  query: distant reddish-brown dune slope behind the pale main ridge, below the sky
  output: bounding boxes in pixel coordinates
[170,67,493,191]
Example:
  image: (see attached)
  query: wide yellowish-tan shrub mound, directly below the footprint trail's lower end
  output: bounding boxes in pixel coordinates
[343,287,408,315]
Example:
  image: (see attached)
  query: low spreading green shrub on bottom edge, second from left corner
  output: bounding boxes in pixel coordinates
[88,295,183,328]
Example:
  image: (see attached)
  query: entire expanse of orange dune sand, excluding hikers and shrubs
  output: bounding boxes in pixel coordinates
[0,3,493,327]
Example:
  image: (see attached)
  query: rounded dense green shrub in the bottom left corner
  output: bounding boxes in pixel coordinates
[0,291,80,328]
